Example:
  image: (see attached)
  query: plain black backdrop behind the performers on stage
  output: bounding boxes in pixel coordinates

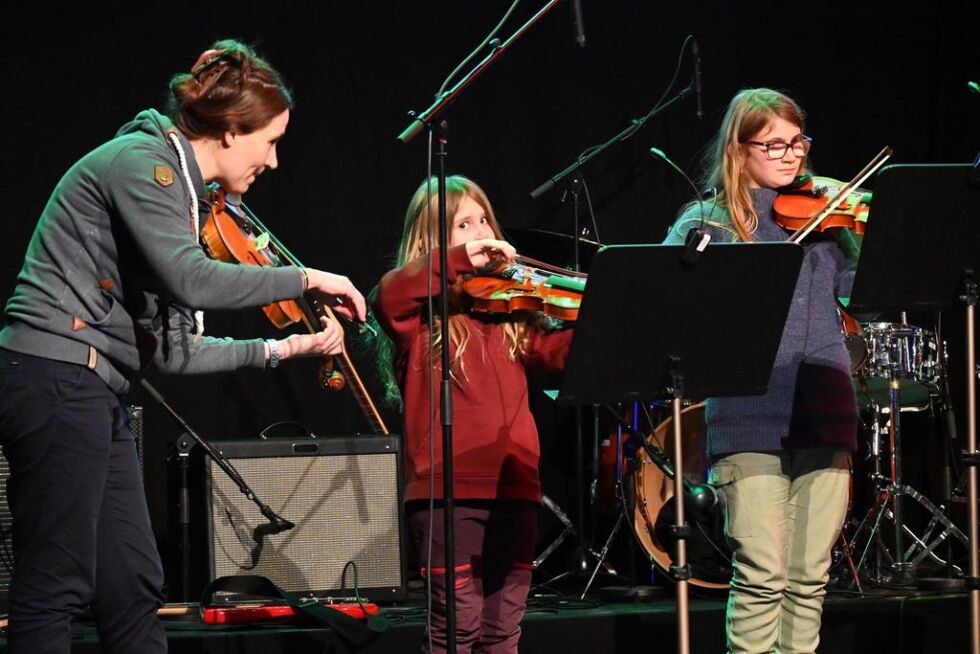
[0,0,980,596]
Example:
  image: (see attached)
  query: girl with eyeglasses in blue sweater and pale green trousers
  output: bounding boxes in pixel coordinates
[665,88,857,653]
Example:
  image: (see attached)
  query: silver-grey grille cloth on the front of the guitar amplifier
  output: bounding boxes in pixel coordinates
[209,453,401,591]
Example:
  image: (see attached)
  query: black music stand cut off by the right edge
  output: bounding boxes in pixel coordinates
[848,164,980,654]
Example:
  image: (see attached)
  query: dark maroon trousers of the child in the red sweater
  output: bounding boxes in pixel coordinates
[407,500,539,654]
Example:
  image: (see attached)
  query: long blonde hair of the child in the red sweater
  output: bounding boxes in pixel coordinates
[395,175,527,376]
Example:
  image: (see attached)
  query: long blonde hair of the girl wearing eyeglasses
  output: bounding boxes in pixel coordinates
[688,88,808,241]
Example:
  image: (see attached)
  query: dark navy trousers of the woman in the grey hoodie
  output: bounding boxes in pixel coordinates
[0,350,167,654]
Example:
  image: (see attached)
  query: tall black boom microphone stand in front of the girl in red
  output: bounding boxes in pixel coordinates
[398,0,559,654]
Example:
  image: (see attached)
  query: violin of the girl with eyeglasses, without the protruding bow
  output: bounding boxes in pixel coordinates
[773,174,871,235]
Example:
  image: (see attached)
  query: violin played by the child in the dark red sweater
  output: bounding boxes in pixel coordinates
[460,257,588,321]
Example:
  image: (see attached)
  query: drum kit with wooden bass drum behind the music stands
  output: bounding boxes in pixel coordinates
[535,314,967,597]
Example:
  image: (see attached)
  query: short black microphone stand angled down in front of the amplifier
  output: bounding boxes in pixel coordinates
[140,379,296,600]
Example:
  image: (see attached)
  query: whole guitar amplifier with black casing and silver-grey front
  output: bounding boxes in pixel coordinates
[206,436,407,602]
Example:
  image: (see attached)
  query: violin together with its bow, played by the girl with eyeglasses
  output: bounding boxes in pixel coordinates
[773,146,892,243]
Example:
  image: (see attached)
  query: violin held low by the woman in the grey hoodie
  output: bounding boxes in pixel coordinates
[201,186,389,434]
